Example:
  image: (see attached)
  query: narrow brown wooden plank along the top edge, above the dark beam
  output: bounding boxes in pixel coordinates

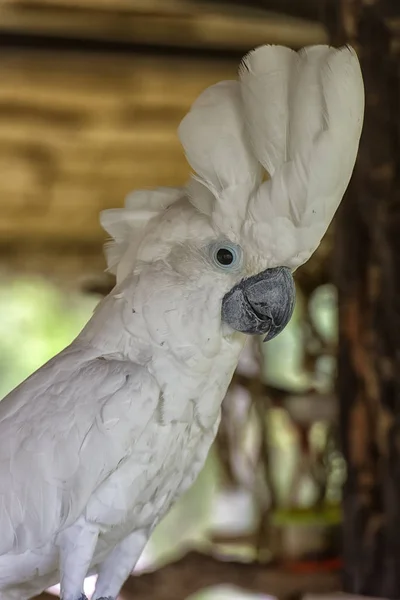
[0,0,327,50]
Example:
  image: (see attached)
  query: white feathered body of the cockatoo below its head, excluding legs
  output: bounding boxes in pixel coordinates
[0,200,244,600]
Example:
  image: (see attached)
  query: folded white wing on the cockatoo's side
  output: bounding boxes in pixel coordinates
[0,349,159,555]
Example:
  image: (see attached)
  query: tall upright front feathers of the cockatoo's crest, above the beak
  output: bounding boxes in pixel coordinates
[242,46,364,268]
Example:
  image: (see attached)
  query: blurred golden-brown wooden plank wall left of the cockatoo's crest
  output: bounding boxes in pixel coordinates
[0,51,236,246]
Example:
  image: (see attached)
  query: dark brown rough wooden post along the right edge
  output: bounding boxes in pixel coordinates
[326,0,400,598]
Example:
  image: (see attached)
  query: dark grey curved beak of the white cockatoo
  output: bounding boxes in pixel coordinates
[222,267,296,342]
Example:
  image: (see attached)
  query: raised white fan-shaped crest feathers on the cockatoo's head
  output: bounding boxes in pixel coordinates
[101,46,364,276]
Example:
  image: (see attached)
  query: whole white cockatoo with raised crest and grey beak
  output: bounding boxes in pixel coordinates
[0,46,364,600]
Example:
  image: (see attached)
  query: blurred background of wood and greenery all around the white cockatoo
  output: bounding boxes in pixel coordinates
[0,0,400,600]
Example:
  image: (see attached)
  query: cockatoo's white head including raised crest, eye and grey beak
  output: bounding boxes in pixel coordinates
[101,46,364,352]
